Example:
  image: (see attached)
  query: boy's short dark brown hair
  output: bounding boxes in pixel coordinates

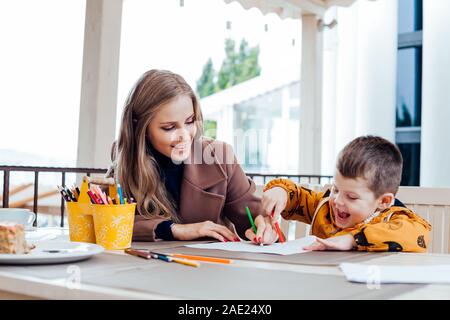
[336,136,403,197]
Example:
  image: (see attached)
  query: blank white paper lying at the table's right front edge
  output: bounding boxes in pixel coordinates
[339,263,450,284]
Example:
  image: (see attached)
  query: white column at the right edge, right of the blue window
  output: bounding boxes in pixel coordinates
[420,0,450,187]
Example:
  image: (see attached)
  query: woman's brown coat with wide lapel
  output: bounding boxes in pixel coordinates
[109,139,262,241]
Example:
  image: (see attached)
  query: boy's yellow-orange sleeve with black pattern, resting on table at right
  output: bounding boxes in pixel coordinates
[336,211,431,252]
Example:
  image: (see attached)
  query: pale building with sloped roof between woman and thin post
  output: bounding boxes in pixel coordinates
[200,70,300,174]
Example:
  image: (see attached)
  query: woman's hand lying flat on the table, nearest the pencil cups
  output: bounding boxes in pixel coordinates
[172,221,240,242]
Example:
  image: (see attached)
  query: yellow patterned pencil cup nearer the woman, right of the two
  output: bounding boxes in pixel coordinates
[91,203,136,250]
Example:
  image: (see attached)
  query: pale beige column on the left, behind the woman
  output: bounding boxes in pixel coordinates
[77,0,122,168]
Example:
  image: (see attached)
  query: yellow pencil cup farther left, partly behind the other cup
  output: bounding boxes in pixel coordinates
[67,202,96,243]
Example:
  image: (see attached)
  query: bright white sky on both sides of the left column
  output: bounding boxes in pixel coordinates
[0,0,301,166]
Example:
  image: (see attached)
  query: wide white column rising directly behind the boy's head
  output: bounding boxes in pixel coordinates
[323,0,397,162]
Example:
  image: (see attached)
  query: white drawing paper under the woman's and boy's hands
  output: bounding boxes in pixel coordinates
[186,236,316,256]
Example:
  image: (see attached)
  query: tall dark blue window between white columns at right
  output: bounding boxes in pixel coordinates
[396,0,423,186]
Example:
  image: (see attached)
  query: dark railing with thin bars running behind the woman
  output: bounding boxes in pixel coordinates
[0,166,332,227]
